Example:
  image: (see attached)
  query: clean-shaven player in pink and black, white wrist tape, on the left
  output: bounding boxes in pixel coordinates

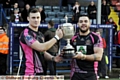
[18,8,63,76]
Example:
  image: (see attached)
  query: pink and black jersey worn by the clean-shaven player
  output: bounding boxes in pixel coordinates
[19,28,46,75]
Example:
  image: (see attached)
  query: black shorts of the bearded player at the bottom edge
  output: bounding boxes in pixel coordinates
[71,72,97,80]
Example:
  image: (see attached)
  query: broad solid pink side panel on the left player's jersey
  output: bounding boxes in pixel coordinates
[20,42,34,75]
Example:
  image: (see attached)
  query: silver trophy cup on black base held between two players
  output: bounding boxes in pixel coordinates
[61,23,75,59]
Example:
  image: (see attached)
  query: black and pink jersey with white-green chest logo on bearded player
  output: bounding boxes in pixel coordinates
[71,32,103,77]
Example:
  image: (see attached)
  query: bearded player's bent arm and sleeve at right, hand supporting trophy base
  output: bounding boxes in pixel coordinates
[74,36,103,61]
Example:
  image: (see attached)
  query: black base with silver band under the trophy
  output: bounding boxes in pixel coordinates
[62,49,75,59]
